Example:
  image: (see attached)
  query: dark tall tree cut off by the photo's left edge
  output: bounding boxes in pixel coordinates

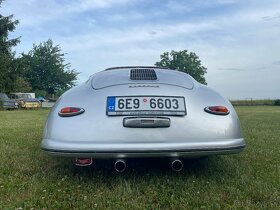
[0,0,20,92]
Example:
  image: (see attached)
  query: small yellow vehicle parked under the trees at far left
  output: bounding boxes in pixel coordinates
[10,93,41,109]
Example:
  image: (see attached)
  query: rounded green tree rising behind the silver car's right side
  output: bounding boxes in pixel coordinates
[155,50,207,85]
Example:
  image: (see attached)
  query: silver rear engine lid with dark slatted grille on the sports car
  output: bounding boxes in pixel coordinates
[91,68,194,89]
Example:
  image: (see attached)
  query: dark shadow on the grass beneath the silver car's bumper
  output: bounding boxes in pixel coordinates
[42,155,238,179]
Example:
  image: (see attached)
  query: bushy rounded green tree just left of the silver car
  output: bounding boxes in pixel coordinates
[21,39,78,94]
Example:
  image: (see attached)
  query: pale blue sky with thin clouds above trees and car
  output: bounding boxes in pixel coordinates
[0,0,280,99]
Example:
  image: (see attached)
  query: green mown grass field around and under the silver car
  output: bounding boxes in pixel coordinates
[0,106,280,209]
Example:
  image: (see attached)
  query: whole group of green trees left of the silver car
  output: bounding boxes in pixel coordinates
[0,0,78,96]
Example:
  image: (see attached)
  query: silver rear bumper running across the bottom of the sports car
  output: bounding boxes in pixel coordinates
[41,138,245,159]
